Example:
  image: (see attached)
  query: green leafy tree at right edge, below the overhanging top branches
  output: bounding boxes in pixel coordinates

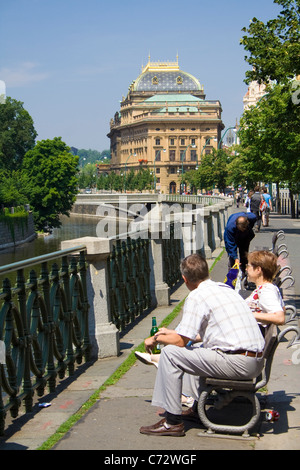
[239,85,300,216]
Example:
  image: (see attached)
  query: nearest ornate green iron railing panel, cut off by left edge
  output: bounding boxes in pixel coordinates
[0,245,90,435]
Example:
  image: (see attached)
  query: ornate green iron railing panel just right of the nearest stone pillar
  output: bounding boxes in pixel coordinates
[108,236,151,331]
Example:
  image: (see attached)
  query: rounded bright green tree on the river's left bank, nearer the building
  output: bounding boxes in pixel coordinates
[23,137,78,230]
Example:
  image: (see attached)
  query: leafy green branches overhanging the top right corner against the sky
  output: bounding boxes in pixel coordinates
[241,0,300,84]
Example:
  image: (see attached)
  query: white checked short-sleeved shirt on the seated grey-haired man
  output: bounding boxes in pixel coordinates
[176,279,264,352]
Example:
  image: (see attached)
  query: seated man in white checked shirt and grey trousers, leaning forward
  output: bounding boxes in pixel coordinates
[140,254,264,436]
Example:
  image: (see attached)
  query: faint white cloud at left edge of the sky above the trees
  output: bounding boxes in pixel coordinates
[0,62,49,88]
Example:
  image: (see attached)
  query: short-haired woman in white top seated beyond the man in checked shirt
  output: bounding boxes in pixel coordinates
[245,251,285,332]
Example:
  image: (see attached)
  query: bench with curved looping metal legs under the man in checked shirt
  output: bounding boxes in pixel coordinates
[198,324,282,437]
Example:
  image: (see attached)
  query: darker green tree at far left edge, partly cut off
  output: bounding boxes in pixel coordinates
[0,97,37,170]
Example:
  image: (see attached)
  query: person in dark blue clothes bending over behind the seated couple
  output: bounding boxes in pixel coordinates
[224,212,256,277]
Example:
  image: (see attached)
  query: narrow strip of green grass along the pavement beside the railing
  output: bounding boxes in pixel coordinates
[36,250,225,450]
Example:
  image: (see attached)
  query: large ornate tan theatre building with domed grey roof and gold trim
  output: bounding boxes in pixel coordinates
[108,58,224,194]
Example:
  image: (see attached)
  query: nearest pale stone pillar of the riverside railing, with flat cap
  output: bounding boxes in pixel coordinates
[61,237,120,358]
